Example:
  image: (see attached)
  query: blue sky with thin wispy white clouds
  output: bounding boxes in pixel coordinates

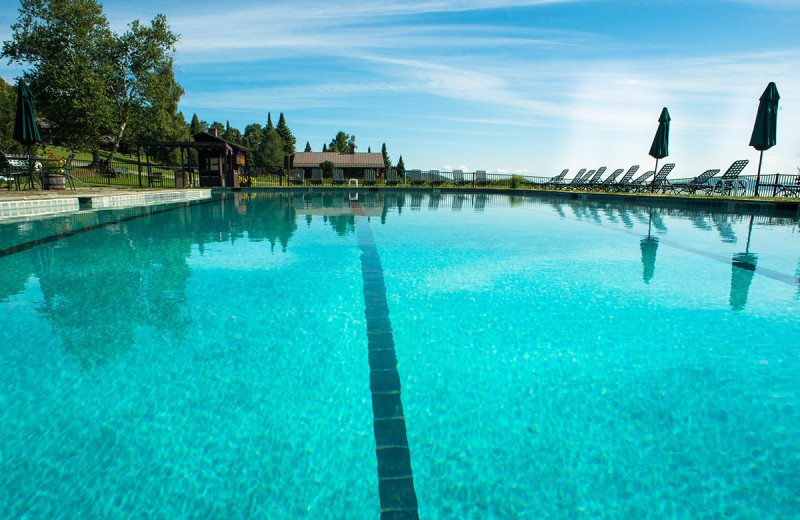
[0,0,800,178]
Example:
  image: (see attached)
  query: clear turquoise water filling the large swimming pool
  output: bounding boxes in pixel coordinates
[0,193,800,519]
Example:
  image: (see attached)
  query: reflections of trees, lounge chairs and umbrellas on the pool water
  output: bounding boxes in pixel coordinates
[0,191,800,367]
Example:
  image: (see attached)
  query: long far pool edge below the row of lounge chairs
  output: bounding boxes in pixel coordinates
[211,186,800,219]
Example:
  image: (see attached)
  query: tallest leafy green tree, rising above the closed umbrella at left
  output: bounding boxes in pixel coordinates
[2,0,183,161]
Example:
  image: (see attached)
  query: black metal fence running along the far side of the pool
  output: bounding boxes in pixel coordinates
[62,161,800,198]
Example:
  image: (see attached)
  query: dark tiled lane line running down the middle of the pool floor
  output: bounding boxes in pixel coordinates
[352,202,419,520]
